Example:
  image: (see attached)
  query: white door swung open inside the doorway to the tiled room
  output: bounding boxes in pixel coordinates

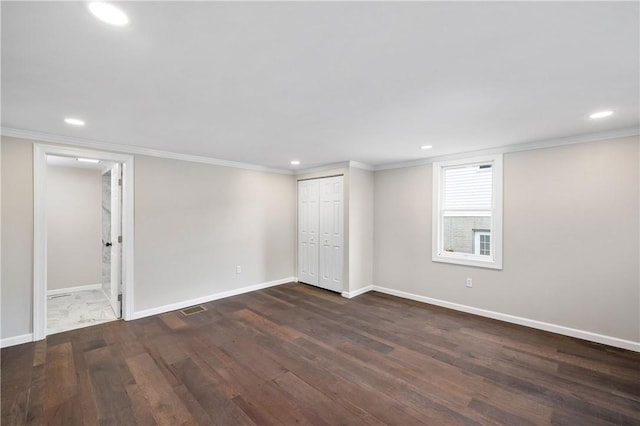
[107,164,122,318]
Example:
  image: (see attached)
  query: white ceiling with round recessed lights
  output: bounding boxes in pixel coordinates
[2,1,640,169]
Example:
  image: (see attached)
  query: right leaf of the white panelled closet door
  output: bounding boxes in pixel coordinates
[318,176,344,292]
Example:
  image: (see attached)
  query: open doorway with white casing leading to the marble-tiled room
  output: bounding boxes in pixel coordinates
[33,144,133,340]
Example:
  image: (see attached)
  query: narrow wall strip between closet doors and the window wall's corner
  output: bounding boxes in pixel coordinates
[349,168,374,292]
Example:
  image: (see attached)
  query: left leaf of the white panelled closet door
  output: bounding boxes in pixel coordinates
[298,180,320,285]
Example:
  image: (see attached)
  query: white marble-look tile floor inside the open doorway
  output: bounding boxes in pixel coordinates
[47,290,117,335]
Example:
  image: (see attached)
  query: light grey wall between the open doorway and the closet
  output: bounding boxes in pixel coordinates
[134,156,296,311]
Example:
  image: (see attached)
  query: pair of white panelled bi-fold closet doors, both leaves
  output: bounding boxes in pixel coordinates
[298,176,344,292]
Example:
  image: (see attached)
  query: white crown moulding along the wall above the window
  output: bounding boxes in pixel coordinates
[373,127,640,171]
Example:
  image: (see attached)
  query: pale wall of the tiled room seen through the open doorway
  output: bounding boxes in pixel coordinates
[46,165,102,290]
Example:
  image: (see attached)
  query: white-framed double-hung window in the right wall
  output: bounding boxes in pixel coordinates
[432,155,502,269]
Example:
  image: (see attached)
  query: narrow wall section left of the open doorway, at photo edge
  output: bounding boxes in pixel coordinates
[1,137,33,339]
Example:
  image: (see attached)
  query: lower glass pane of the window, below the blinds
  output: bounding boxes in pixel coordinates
[442,216,491,255]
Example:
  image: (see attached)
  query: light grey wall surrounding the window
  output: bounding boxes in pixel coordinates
[374,137,640,342]
